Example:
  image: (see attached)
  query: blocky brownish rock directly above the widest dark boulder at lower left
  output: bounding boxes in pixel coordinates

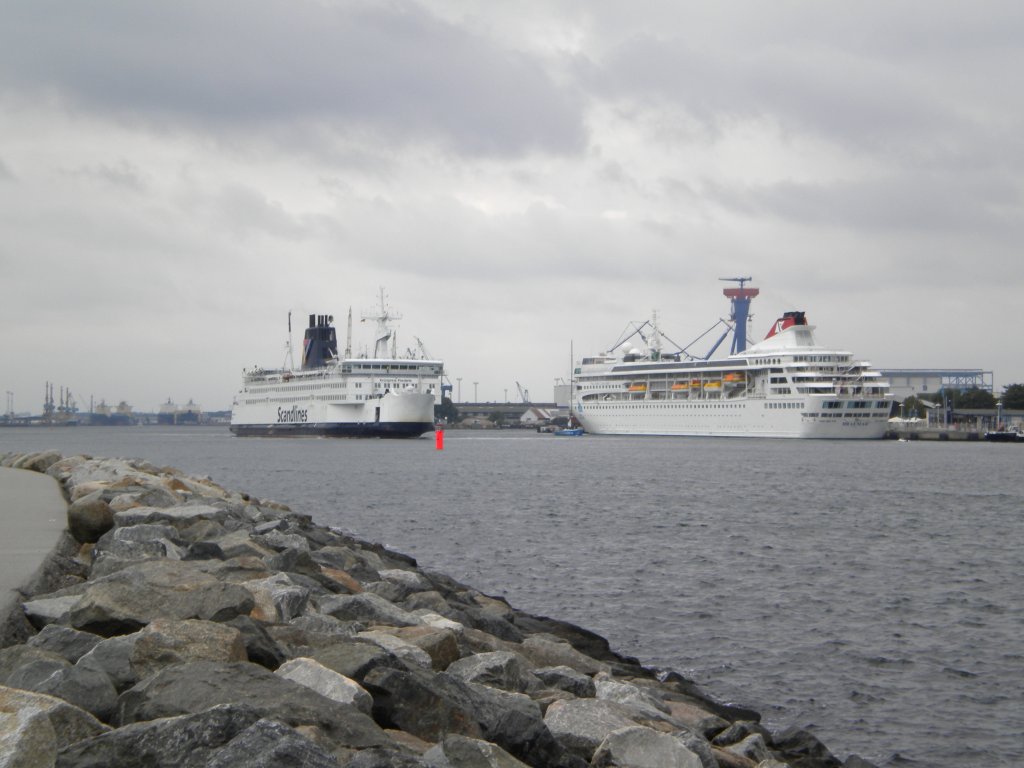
[130,618,248,680]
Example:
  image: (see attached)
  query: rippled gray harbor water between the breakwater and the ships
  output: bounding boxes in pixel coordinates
[0,427,1024,768]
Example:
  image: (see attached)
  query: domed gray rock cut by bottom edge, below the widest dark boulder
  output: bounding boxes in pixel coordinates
[206,720,338,768]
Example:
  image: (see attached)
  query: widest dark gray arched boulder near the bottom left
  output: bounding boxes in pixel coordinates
[116,662,394,749]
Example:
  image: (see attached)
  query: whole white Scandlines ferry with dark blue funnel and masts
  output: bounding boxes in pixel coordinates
[230,292,444,437]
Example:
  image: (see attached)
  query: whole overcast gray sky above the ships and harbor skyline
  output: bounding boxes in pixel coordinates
[0,0,1024,413]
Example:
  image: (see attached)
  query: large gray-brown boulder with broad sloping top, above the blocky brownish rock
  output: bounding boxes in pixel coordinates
[69,560,254,636]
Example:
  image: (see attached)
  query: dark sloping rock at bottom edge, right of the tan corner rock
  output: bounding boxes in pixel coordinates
[57,705,259,768]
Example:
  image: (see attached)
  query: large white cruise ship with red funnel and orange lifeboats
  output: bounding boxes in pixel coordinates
[572,278,893,439]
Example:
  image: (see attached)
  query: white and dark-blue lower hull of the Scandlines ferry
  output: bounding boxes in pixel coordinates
[231,392,435,437]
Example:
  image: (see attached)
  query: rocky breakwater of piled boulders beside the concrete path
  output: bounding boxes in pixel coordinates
[0,454,868,768]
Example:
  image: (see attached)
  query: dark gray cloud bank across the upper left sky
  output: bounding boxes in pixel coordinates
[0,0,584,156]
